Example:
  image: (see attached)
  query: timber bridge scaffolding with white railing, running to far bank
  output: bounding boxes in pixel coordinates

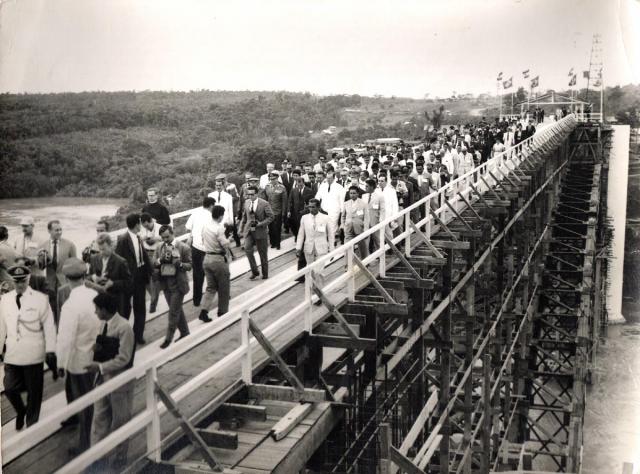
[3,115,606,473]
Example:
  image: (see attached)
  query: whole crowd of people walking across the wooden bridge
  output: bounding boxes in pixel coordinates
[0,115,535,467]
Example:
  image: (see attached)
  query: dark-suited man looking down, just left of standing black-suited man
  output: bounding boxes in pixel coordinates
[85,233,131,316]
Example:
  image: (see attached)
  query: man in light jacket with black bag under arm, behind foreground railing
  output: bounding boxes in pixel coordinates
[85,293,135,472]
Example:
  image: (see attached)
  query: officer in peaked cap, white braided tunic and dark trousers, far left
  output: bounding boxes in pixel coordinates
[0,265,58,430]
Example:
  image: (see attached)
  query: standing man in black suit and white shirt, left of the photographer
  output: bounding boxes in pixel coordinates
[116,214,151,344]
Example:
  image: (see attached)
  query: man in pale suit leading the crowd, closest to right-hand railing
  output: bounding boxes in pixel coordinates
[296,199,336,265]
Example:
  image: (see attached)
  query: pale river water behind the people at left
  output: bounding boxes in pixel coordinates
[0,197,127,253]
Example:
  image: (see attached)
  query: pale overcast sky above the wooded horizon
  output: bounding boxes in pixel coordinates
[0,0,640,98]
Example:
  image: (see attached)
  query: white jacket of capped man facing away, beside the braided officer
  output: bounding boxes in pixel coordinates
[56,286,100,374]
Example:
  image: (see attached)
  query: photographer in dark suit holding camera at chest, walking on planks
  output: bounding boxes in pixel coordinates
[153,226,191,349]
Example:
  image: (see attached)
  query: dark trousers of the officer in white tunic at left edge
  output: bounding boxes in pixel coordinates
[4,363,44,426]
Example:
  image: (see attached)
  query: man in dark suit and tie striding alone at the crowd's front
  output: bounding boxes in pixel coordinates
[240,186,273,280]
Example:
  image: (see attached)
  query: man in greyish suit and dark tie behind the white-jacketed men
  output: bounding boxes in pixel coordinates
[38,220,76,324]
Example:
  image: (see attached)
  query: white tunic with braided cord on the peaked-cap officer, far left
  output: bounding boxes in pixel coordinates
[0,287,56,365]
